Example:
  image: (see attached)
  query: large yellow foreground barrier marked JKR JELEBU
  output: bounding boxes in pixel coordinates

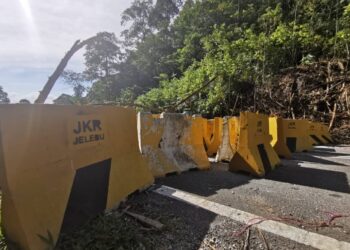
[0,104,153,250]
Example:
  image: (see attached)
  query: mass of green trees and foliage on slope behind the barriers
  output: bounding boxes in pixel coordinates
[62,0,350,115]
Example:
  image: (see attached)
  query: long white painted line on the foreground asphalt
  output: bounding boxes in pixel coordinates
[154,186,350,250]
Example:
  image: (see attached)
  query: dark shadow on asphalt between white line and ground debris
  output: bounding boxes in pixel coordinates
[128,192,217,249]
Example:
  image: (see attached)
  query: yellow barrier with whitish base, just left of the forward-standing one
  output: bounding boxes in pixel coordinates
[215,117,239,162]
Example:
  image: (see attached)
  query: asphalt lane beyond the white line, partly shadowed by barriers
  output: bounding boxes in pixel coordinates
[158,146,350,245]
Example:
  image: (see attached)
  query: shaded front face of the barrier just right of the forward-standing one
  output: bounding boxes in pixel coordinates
[283,119,313,153]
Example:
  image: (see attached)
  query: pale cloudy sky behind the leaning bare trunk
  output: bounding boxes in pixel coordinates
[0,0,132,103]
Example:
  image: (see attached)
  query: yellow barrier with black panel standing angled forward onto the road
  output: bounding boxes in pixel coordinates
[229,112,280,176]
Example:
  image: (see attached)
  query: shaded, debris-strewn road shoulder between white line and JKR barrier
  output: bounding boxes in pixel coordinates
[58,191,318,250]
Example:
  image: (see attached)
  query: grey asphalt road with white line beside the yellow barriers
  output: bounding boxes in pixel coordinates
[57,146,350,250]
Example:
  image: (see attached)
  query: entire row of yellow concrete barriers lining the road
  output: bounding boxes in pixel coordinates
[0,104,332,249]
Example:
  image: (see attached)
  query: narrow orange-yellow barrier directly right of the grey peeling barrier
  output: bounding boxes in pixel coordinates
[201,117,223,156]
